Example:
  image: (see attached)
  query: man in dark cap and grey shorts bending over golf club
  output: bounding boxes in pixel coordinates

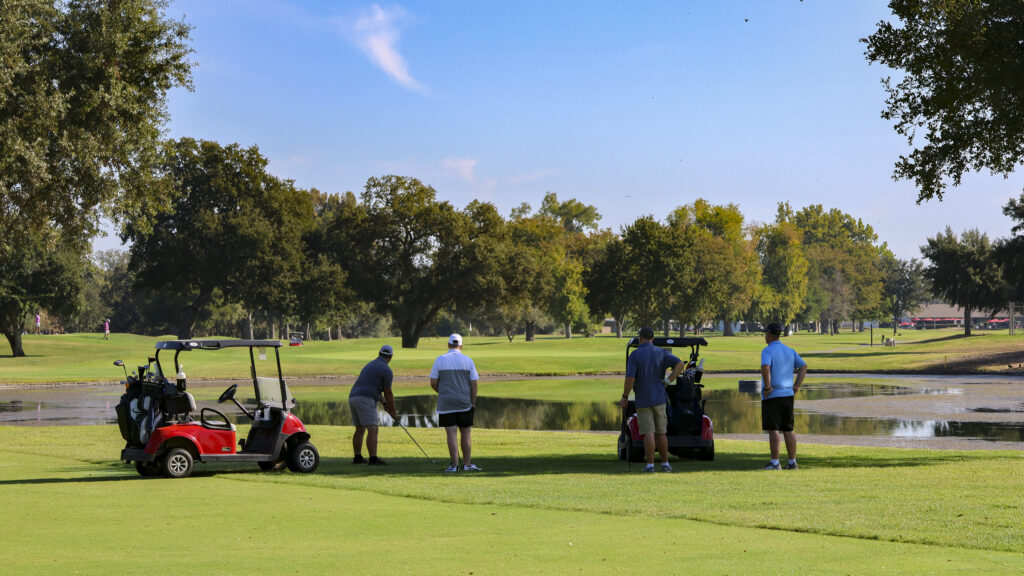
[348,344,398,466]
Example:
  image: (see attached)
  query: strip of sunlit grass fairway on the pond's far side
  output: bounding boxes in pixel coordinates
[0,330,1024,383]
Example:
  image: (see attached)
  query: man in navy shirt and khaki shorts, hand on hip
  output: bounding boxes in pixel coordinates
[620,326,685,472]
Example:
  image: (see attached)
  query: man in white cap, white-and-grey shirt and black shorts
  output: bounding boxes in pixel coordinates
[430,334,480,472]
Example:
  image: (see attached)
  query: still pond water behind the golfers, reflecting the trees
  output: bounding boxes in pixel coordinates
[0,383,1024,442]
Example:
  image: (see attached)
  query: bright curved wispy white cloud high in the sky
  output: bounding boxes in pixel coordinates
[350,4,426,93]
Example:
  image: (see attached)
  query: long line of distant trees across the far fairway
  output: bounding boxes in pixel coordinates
[14,132,950,347]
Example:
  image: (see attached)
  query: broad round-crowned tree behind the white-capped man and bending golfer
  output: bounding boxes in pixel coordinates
[331,175,502,347]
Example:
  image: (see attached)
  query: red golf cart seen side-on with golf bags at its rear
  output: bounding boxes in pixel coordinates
[114,340,319,478]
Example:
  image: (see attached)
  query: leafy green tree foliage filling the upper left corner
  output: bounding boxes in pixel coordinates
[0,0,191,237]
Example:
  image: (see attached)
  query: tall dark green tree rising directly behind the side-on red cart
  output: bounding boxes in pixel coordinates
[124,138,313,338]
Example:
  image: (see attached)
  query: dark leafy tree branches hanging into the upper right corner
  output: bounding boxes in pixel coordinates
[862,0,1024,202]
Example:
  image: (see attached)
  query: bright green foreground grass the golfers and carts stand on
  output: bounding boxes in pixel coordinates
[0,426,1024,575]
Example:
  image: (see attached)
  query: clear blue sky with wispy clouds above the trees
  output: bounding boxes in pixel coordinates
[108,0,1024,258]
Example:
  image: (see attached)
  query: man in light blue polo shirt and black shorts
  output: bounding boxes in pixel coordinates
[761,322,807,470]
